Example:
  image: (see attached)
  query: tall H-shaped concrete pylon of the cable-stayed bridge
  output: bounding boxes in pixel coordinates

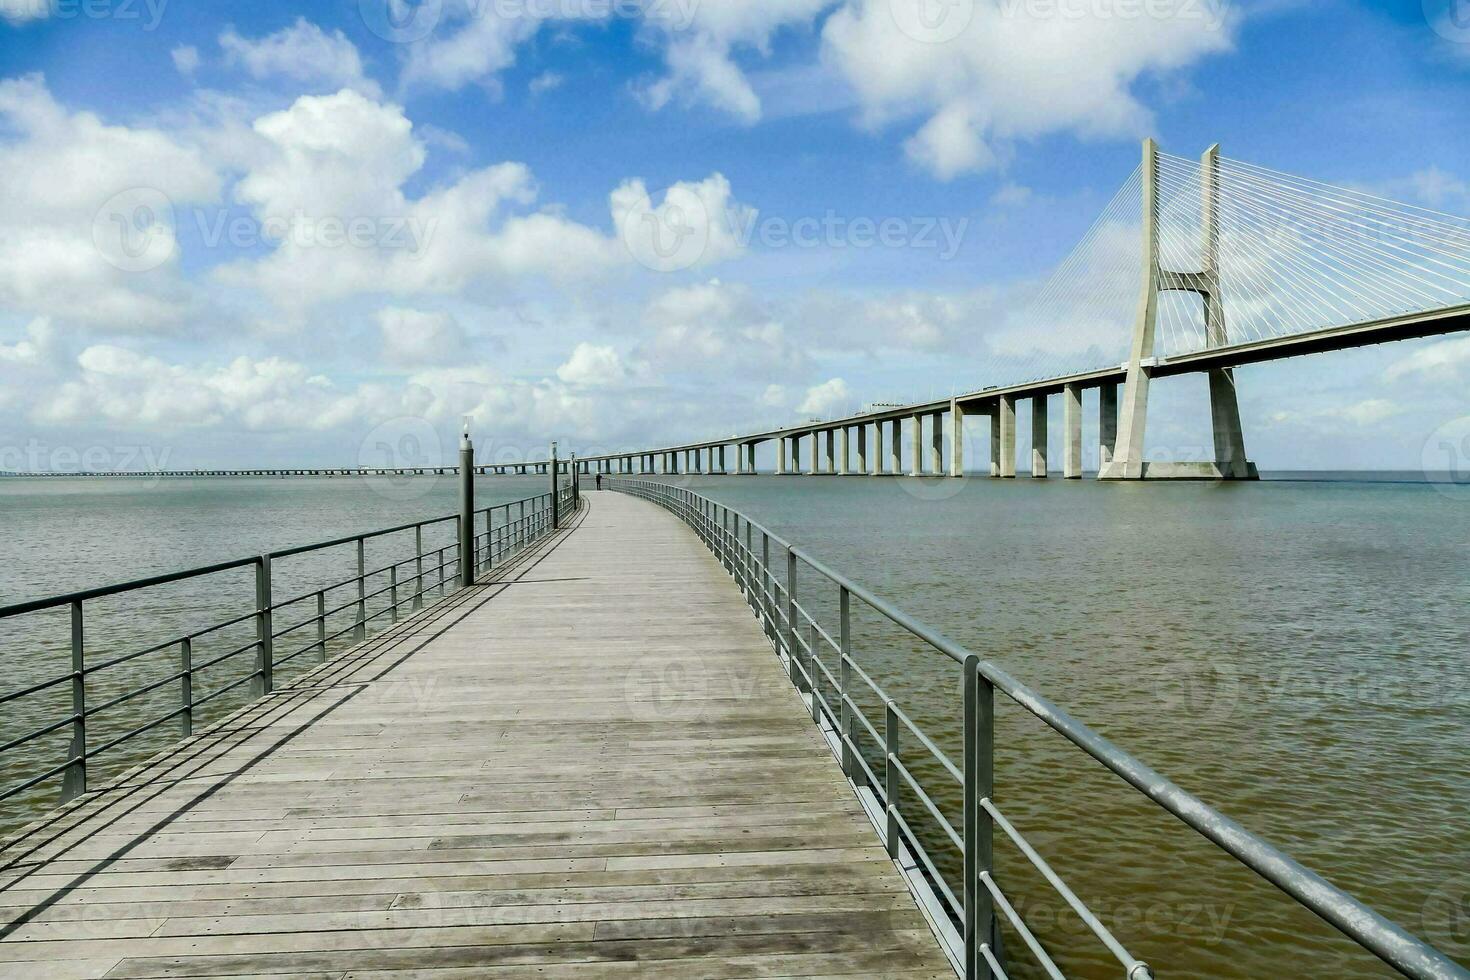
[1098,140,1260,480]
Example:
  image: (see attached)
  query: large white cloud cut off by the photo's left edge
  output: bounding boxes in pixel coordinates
[0,75,221,329]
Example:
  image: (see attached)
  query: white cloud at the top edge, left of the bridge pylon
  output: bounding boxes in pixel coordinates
[823,0,1232,179]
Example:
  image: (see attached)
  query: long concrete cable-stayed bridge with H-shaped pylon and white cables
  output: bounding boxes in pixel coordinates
[581,140,1470,479]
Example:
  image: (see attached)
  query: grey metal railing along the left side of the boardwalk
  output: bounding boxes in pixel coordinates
[0,483,578,802]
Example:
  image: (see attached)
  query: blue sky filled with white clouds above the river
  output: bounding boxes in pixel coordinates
[0,0,1470,469]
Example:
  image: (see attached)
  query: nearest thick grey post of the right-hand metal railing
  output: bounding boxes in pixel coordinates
[964,654,997,980]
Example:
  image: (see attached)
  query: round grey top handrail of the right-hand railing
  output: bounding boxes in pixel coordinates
[609,475,1470,980]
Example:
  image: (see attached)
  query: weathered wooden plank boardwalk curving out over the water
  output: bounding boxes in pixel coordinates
[0,494,954,980]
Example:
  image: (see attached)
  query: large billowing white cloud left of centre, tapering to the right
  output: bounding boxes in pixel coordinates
[218,90,643,309]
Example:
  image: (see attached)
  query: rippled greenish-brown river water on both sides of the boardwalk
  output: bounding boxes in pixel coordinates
[0,475,1470,977]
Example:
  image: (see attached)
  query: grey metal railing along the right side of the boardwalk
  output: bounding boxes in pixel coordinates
[606,479,1470,980]
